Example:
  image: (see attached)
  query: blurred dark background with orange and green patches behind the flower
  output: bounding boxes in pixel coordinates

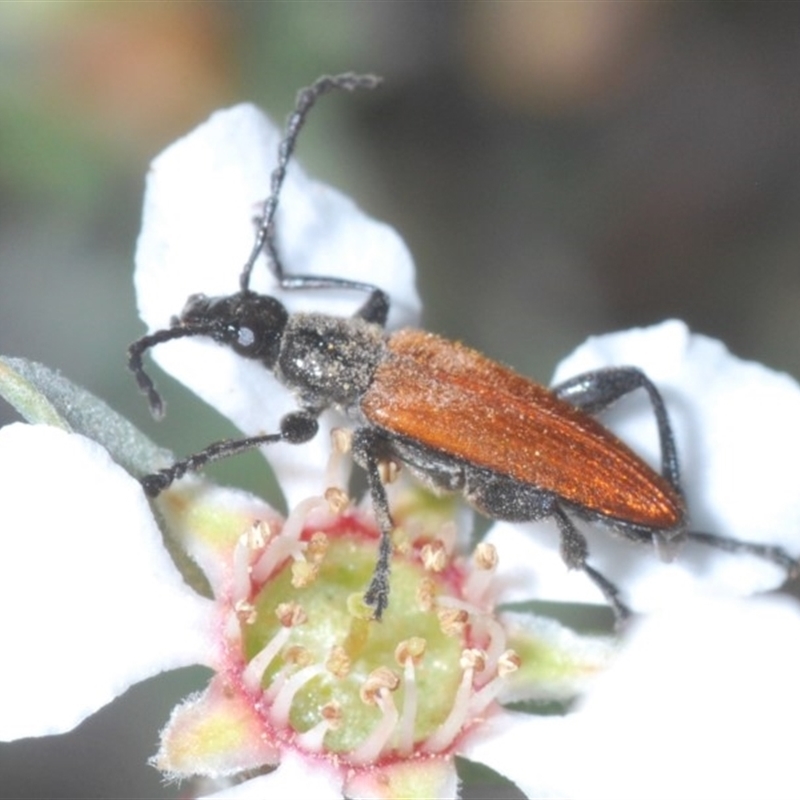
[0,2,800,798]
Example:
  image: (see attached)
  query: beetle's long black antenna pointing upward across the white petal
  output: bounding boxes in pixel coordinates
[239,72,381,292]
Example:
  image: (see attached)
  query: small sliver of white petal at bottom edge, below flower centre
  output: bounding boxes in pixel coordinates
[201,752,342,800]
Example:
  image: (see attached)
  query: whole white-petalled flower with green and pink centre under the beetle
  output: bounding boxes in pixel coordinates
[0,95,800,798]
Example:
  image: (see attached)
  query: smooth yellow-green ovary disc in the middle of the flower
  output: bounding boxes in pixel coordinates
[242,538,464,753]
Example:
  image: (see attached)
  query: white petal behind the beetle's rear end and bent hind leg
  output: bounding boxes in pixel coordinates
[495,320,800,611]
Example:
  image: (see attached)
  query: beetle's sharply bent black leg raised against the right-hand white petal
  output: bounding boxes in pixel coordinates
[551,367,683,497]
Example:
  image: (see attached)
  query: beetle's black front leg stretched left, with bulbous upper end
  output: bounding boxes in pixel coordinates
[139,410,319,497]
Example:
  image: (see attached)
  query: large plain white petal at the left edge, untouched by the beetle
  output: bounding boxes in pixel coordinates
[0,424,210,739]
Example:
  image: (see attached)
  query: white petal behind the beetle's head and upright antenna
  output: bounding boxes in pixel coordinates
[135,105,419,506]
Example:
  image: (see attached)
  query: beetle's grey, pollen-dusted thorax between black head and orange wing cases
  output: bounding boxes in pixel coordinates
[275,314,386,409]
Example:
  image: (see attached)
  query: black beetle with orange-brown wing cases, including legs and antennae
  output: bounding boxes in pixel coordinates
[128,73,800,623]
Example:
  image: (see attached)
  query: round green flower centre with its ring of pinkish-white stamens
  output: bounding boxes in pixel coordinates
[231,498,516,765]
